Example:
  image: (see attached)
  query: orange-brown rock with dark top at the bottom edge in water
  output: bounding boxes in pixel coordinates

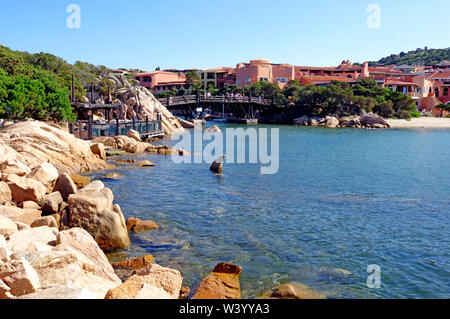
[192,263,242,299]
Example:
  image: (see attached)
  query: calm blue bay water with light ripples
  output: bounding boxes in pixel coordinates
[89,125,450,298]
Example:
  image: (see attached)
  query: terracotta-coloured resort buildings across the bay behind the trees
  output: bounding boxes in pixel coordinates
[135,58,450,115]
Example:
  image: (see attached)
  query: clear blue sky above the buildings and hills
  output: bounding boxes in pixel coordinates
[0,0,450,70]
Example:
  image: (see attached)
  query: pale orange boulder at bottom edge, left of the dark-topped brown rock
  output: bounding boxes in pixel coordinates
[105,264,183,299]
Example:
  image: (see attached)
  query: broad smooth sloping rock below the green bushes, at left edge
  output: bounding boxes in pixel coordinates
[0,120,107,173]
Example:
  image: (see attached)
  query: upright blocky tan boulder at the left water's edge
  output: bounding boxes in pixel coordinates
[68,181,130,249]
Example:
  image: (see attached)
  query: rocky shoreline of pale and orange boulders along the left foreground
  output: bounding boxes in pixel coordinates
[0,120,324,299]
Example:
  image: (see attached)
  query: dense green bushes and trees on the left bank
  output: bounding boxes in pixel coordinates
[0,46,106,121]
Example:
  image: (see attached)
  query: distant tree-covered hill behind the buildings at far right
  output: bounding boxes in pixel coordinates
[369,47,450,66]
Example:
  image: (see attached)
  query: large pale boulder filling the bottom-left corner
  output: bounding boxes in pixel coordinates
[0,226,121,299]
